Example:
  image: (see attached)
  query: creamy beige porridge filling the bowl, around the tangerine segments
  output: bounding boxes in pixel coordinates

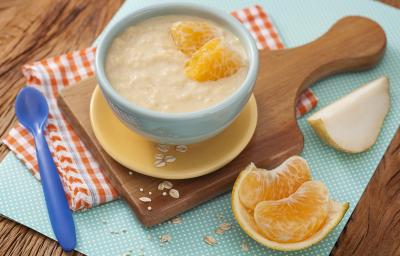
[105,15,248,112]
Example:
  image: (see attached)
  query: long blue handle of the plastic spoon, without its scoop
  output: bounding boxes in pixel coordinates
[35,130,76,251]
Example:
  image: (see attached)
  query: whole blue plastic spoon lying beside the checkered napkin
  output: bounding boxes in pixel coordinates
[15,87,76,251]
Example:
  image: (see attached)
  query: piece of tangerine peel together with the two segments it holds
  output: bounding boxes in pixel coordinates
[232,156,349,251]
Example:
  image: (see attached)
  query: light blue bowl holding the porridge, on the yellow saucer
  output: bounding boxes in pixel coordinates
[95,3,259,145]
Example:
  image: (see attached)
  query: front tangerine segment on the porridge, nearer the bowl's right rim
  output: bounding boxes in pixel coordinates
[185,37,242,82]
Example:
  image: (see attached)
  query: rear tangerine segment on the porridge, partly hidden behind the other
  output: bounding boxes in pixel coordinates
[171,21,218,56]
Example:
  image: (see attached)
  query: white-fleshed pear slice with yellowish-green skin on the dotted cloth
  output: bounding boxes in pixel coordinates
[307,76,390,153]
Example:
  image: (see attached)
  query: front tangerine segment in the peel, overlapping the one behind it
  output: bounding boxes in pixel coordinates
[254,181,329,243]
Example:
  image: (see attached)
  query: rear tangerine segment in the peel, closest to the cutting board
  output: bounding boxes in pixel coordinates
[239,156,311,209]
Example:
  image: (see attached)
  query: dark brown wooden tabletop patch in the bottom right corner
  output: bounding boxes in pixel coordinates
[332,129,400,256]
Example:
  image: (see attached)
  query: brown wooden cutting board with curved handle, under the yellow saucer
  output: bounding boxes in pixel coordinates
[59,17,386,226]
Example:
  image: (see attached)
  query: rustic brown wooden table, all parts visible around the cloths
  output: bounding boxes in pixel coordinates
[0,0,400,256]
